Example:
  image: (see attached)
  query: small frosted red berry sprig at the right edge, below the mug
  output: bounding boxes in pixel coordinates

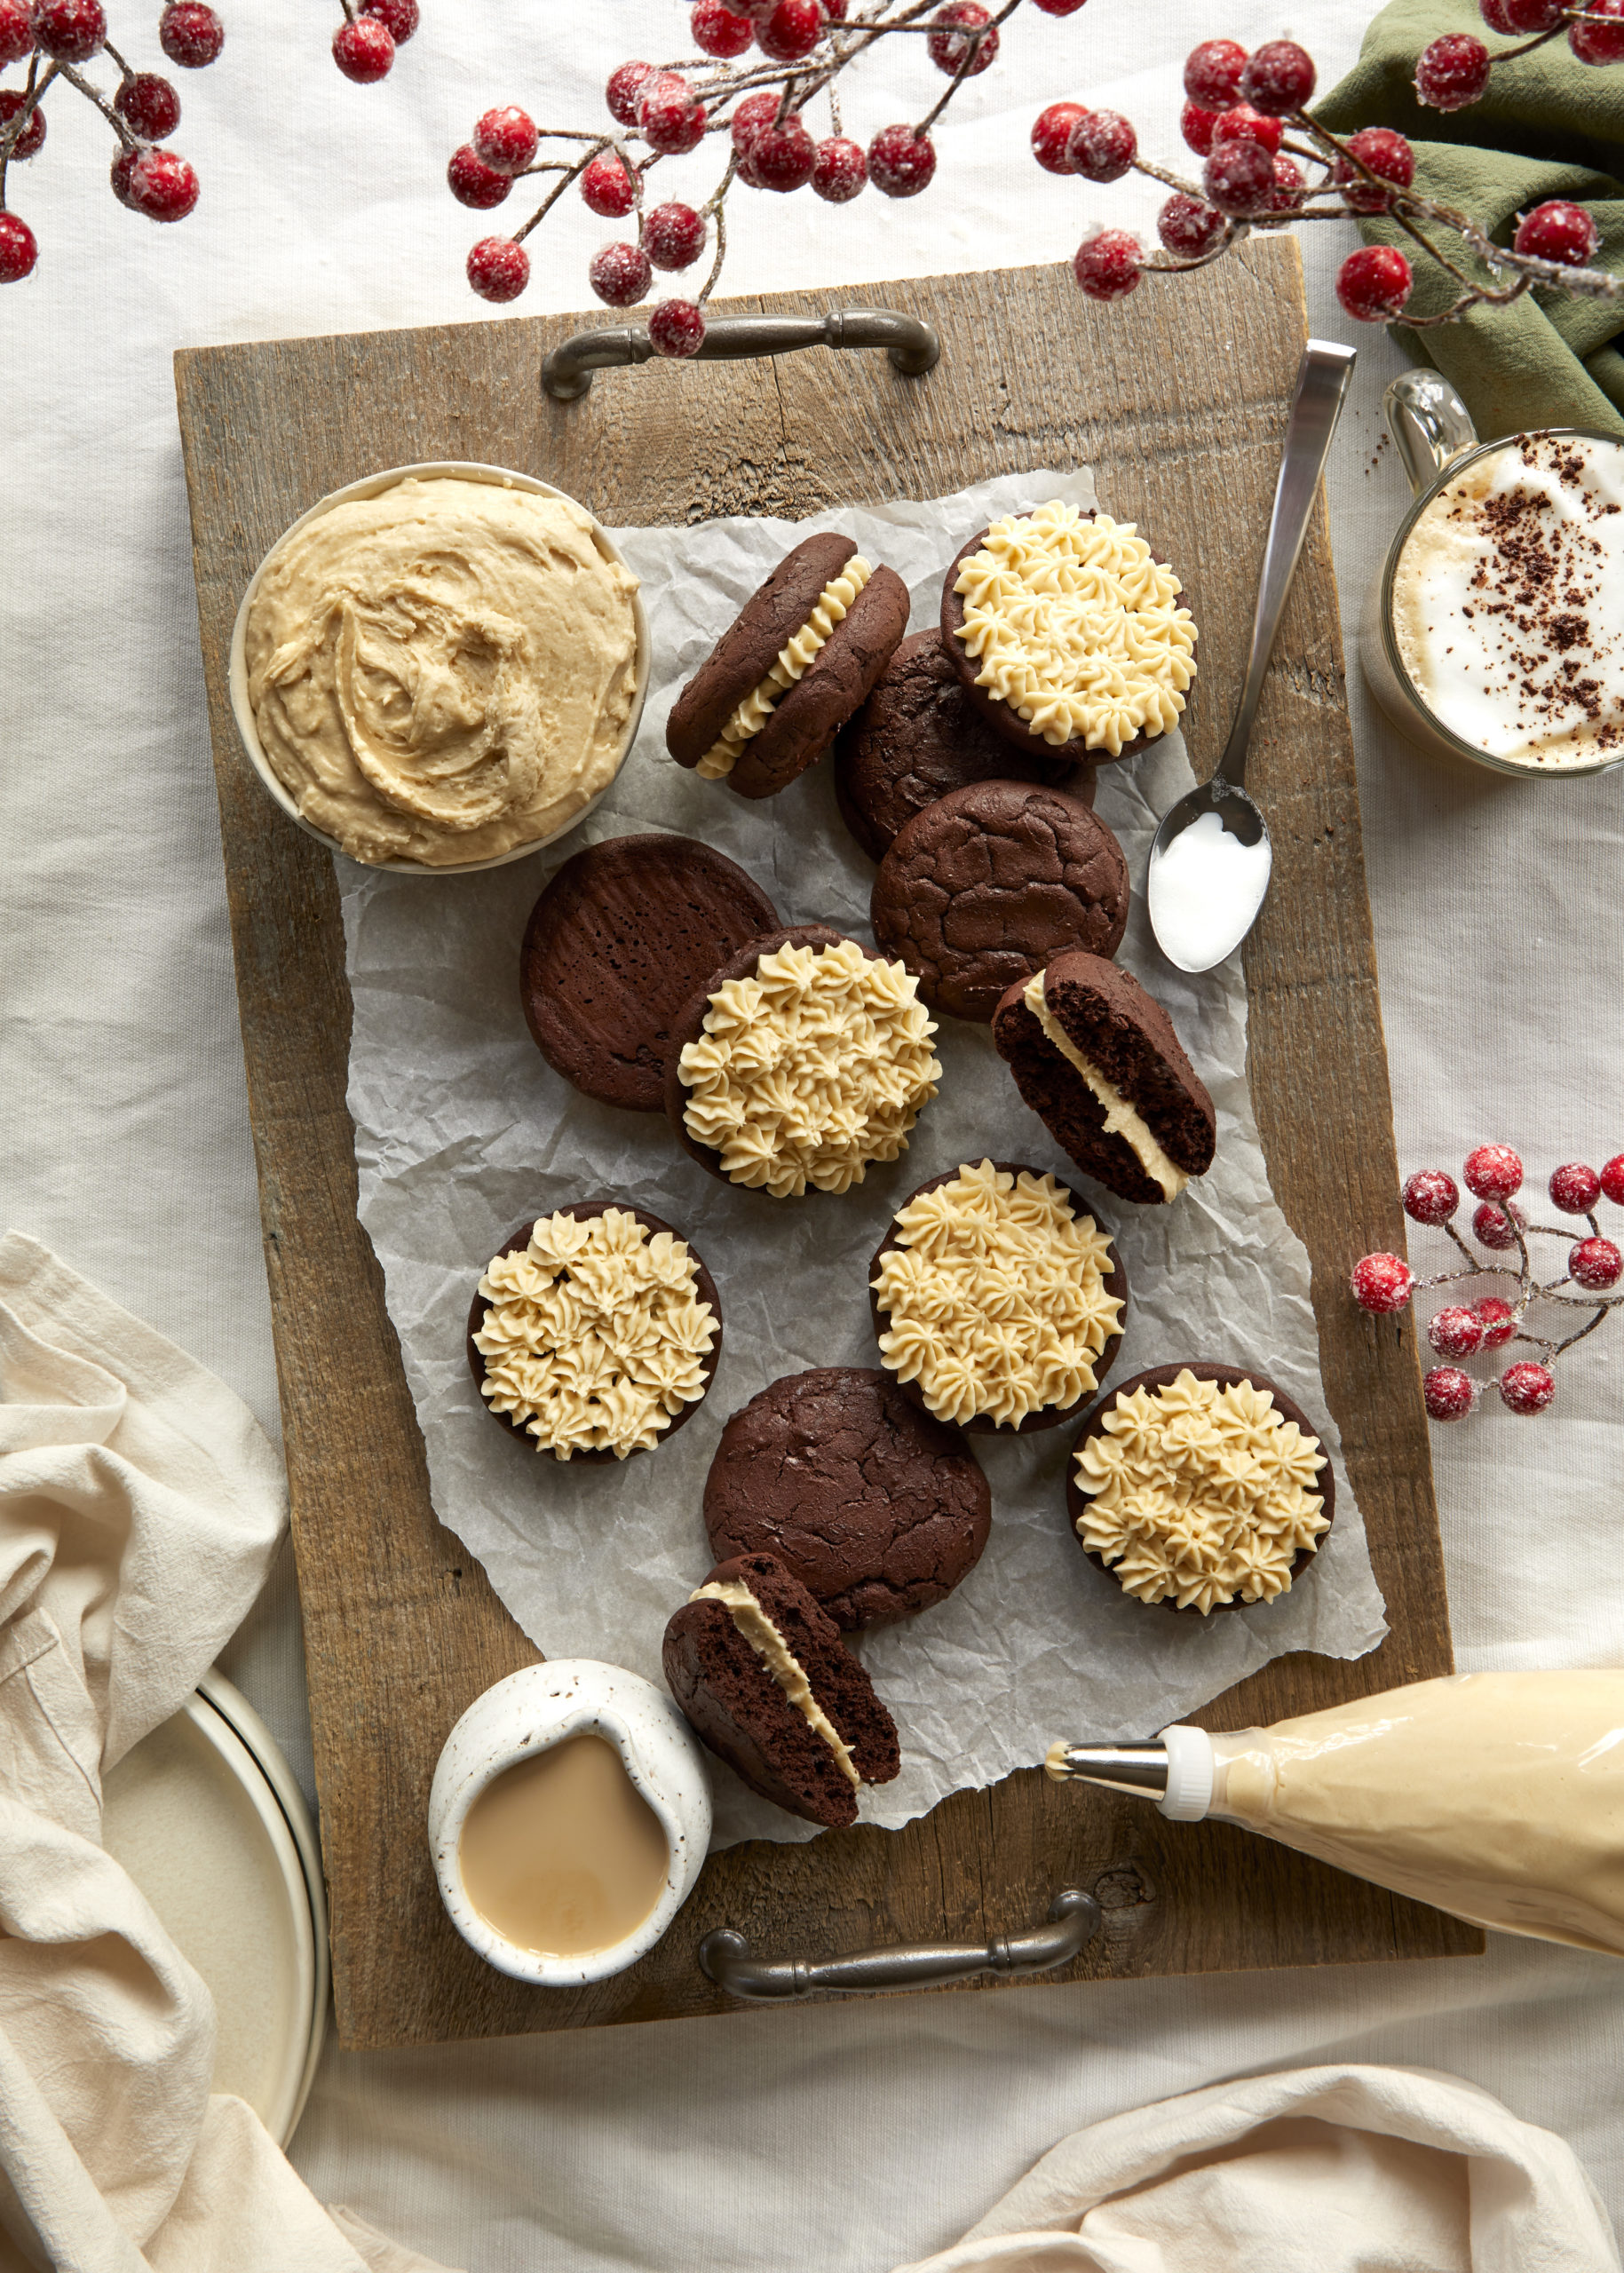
[1351,1144,1624,1421]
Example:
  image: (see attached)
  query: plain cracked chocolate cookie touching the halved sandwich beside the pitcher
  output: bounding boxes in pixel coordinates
[705,1366,992,1632]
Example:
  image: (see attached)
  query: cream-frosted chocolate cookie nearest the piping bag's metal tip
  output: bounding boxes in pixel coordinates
[1066,1359,1335,1616]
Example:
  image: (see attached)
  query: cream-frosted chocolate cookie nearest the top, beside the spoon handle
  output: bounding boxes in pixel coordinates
[942,500,1196,766]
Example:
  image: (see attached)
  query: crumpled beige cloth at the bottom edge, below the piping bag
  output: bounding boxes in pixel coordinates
[899,2063,1620,2273]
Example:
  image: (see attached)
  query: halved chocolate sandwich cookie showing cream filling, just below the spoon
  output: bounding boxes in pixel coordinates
[992,954,1216,1207]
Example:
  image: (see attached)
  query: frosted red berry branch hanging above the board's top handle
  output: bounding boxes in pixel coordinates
[446,0,1082,341]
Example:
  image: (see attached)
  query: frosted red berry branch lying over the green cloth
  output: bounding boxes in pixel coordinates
[1033,15,1624,328]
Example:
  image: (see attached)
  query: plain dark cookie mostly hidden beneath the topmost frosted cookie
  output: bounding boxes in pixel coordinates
[835,625,1094,859]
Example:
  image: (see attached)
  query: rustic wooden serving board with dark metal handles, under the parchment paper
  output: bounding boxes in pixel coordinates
[175,239,1483,2046]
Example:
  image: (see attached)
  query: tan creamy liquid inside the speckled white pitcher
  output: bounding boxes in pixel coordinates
[457,1737,671,1957]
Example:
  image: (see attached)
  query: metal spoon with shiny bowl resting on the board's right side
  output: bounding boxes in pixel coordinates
[1146,338,1356,970]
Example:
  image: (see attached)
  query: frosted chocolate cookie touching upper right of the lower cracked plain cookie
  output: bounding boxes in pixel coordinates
[869,1160,1129,1437]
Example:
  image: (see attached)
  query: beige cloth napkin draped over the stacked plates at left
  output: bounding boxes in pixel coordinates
[0,1232,455,2273]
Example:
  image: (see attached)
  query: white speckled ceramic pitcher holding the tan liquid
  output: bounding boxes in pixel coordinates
[428,1657,709,1989]
